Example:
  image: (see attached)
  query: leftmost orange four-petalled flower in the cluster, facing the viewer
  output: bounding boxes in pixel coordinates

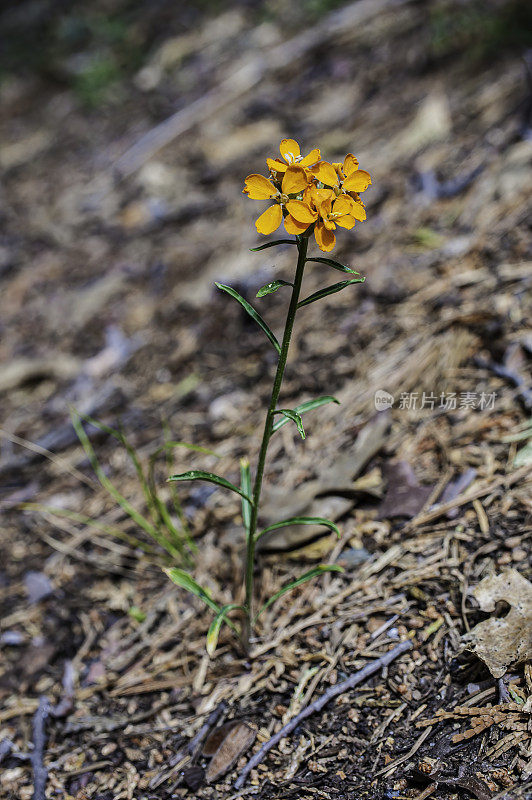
[242,166,317,236]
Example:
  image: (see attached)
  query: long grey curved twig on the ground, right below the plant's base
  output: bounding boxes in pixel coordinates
[235,639,412,789]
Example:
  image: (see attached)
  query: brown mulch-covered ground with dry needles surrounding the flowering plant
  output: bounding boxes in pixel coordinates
[0,0,532,800]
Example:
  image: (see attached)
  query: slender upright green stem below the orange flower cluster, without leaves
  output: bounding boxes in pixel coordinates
[243,236,308,649]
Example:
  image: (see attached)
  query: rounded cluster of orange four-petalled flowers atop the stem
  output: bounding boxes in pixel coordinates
[242,139,371,252]
